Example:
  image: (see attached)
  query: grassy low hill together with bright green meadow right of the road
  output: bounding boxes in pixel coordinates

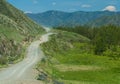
[40,29,120,84]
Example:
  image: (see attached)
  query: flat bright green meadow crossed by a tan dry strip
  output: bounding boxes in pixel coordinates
[51,50,120,84]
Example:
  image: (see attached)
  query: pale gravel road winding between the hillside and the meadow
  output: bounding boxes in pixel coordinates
[0,33,52,84]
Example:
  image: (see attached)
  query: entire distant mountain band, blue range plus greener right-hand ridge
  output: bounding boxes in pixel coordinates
[27,10,120,27]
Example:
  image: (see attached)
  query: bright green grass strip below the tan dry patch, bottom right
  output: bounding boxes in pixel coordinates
[60,70,120,84]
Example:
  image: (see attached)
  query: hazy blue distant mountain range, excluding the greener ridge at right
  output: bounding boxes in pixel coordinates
[27,10,120,26]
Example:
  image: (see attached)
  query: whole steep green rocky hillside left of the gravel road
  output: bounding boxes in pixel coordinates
[0,0,44,65]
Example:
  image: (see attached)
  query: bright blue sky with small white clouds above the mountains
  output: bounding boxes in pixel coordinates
[7,0,120,13]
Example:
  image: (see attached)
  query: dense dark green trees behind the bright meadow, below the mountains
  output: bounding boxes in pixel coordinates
[55,25,120,58]
